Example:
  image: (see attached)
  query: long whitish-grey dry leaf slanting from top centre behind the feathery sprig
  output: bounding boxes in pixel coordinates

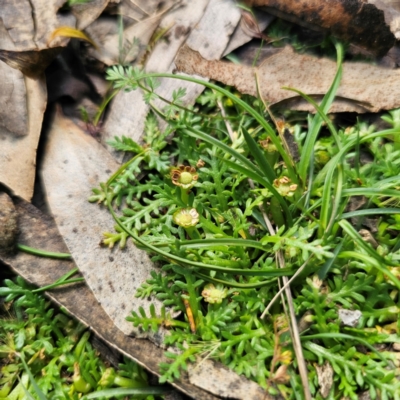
[103,0,240,161]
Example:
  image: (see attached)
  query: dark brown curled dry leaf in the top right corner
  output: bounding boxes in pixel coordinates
[246,0,395,57]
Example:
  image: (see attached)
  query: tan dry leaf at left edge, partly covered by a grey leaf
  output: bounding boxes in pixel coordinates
[0,71,47,201]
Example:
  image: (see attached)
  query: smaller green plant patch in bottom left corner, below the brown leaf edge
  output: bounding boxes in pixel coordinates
[0,277,168,400]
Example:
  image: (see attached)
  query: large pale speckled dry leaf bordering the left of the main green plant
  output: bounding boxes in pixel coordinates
[41,112,161,334]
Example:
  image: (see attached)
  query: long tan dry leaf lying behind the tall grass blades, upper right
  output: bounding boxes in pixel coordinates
[176,46,400,112]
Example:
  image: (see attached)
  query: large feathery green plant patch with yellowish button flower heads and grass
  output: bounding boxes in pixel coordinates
[90,44,400,399]
